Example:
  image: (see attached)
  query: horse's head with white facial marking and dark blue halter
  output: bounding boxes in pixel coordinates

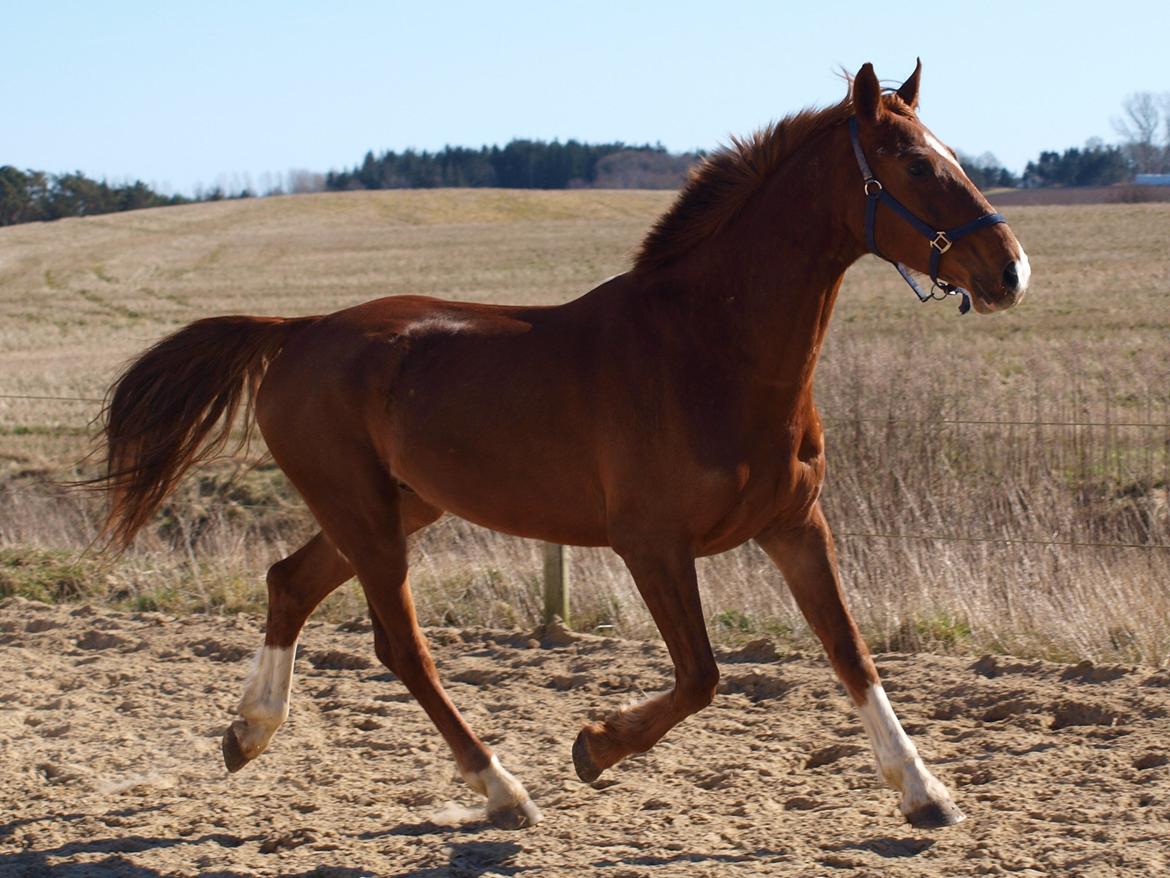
[849,62,1031,313]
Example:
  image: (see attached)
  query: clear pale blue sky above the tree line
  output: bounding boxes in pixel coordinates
[0,0,1170,192]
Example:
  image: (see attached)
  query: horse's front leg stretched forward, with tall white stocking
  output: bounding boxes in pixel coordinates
[756,503,963,826]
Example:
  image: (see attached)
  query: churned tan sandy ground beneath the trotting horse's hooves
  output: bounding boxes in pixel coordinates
[0,598,1170,878]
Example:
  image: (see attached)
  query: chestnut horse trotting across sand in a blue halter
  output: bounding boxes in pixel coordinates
[93,64,1028,828]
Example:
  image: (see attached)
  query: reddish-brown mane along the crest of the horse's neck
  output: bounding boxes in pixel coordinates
[634,91,913,272]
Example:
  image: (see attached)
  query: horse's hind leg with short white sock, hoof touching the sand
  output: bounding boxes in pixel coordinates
[285,450,541,829]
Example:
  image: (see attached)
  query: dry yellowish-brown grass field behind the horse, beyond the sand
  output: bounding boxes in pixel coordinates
[0,190,1170,665]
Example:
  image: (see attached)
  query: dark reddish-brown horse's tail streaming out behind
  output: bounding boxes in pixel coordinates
[85,316,317,549]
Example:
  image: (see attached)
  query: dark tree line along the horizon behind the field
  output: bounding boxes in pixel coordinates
[0,91,1170,226]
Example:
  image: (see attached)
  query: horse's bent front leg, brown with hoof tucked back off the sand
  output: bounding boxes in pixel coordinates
[573,544,720,783]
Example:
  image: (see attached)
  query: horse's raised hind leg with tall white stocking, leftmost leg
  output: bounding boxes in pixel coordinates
[222,533,353,771]
